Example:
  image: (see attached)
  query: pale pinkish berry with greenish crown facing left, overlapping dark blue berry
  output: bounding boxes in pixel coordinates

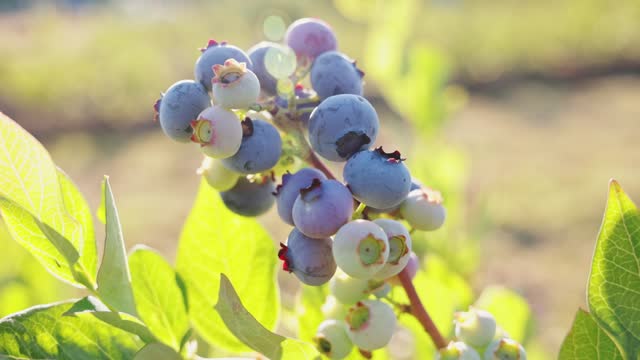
[191,105,242,159]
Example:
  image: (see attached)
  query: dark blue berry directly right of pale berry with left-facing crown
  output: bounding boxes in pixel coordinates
[222,120,282,174]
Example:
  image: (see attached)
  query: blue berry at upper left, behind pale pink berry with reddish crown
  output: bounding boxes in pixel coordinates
[194,42,253,91]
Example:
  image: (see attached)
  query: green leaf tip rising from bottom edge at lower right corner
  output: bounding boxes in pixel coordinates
[558,309,622,360]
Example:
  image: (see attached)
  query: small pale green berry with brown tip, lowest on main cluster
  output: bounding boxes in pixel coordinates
[313,320,353,360]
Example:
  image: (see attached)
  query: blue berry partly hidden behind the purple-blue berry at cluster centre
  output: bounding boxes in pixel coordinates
[276,168,327,225]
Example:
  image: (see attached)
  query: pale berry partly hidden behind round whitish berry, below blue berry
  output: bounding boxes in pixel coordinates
[373,219,411,280]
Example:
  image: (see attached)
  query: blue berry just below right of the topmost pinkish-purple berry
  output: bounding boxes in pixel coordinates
[310,51,364,99]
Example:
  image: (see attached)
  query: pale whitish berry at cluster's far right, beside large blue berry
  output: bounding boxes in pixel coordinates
[400,186,446,231]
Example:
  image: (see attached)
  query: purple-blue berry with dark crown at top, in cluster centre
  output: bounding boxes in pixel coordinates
[292,179,353,238]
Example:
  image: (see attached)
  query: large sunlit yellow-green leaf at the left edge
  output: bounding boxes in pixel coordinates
[0,113,96,287]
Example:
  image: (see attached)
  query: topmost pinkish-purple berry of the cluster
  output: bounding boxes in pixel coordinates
[284,18,338,61]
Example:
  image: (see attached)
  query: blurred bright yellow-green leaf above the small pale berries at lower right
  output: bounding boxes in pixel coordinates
[474,286,533,344]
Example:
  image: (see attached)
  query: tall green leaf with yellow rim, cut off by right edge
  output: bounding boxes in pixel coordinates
[588,180,640,359]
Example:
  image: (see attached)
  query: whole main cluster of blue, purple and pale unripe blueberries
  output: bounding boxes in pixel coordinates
[155,19,445,359]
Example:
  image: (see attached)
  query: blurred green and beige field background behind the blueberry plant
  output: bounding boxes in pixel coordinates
[0,0,640,353]
